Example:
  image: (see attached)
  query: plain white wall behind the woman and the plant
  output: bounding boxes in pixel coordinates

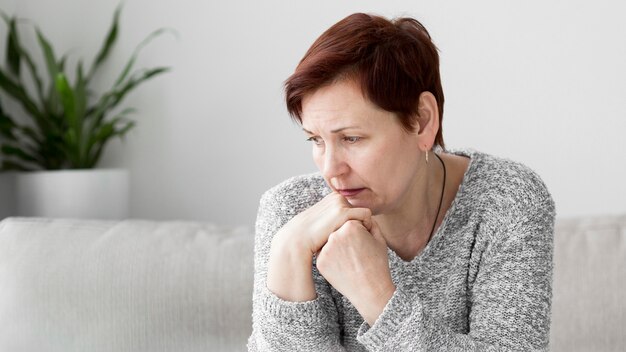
[0,0,626,225]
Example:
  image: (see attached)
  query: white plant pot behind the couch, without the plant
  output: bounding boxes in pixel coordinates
[13,169,129,220]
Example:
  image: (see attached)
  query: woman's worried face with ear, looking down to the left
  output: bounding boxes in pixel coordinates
[301,79,423,215]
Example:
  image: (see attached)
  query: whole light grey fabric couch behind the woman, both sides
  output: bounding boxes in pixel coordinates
[0,216,626,352]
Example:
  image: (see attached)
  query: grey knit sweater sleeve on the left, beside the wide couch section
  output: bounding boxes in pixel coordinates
[248,183,343,352]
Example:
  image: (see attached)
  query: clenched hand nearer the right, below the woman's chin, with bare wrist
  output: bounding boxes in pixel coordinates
[317,220,396,326]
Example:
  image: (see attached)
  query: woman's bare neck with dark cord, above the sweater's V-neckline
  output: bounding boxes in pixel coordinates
[374,153,444,260]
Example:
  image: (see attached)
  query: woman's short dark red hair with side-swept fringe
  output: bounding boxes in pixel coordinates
[285,13,444,147]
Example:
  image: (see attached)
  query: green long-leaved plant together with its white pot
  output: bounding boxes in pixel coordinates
[0,7,169,218]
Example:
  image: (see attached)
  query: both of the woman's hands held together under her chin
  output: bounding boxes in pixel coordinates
[267,192,395,326]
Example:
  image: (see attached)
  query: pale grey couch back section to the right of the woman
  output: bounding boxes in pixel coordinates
[550,216,626,351]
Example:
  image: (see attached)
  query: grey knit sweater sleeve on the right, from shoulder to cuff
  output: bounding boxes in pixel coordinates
[357,196,554,351]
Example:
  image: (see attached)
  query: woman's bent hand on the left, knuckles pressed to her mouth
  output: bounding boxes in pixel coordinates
[266,192,372,302]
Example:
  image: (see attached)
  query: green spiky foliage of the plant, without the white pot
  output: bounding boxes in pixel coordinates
[0,5,169,170]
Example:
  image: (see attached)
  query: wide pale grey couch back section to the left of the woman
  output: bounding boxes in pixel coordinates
[0,218,254,352]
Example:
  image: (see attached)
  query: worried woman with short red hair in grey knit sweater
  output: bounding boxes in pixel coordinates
[248,14,554,351]
